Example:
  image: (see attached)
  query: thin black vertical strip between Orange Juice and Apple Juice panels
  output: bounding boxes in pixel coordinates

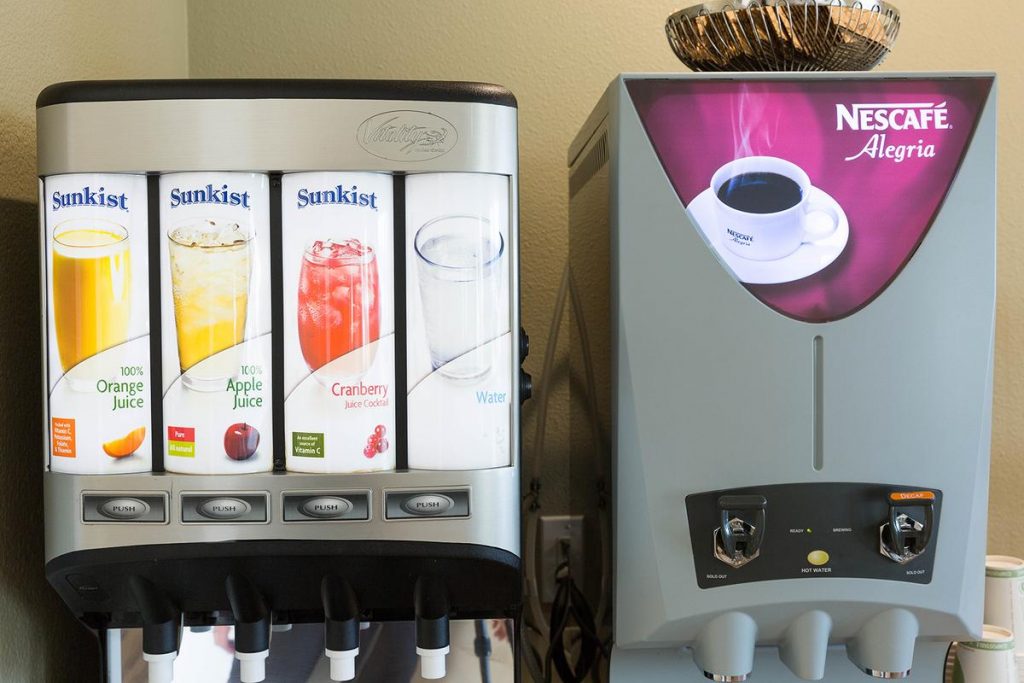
[145,173,164,472]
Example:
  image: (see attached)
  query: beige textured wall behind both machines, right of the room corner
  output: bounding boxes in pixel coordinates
[188,0,1024,554]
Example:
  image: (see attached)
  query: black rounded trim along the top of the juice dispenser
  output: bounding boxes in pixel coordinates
[36,79,517,109]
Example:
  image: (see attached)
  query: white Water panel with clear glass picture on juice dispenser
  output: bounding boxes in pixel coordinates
[406,173,513,470]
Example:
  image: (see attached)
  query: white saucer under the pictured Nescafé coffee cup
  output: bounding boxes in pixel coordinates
[687,187,850,285]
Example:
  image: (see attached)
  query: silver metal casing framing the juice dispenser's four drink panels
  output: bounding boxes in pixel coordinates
[38,88,520,561]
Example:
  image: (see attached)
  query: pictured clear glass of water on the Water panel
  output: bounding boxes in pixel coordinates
[414,216,506,380]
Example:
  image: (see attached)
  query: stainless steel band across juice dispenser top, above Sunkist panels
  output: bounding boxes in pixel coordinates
[37,99,517,176]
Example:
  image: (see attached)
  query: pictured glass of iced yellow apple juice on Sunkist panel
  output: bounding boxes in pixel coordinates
[167,219,252,391]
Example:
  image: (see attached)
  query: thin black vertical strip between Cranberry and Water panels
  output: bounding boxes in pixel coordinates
[392,173,409,471]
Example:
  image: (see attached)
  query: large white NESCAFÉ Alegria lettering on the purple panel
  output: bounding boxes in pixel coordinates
[836,101,952,164]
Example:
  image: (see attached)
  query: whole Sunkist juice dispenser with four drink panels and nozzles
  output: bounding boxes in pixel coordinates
[37,80,529,681]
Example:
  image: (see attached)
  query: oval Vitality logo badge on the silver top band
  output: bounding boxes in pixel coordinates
[356,110,459,161]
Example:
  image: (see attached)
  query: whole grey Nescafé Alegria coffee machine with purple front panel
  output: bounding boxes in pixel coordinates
[569,68,995,683]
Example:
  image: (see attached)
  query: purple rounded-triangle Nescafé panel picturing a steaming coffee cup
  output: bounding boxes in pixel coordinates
[627,77,992,323]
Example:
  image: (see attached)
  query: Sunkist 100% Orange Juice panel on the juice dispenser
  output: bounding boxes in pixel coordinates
[42,173,153,474]
